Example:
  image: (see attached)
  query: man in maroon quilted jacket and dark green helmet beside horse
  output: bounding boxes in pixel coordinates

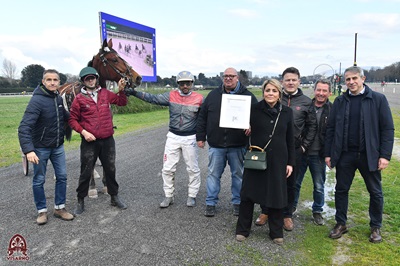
[69,67,127,214]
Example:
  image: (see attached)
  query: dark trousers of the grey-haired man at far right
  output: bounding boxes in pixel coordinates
[335,152,383,228]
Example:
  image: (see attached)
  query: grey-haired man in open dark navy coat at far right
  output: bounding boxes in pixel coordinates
[325,66,394,243]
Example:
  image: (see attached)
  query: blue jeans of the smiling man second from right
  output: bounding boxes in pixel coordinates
[294,155,326,213]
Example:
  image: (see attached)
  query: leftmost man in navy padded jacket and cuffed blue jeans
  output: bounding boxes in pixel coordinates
[18,69,74,225]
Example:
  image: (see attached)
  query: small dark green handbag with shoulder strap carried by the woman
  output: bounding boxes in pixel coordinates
[244,105,282,170]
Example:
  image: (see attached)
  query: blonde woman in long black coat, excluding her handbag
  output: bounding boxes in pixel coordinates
[236,79,295,244]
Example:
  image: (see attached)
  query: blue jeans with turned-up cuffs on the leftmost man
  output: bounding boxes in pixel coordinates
[32,145,67,212]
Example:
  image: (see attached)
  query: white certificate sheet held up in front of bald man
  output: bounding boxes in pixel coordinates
[219,94,251,129]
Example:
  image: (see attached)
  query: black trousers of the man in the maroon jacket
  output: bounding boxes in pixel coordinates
[76,136,119,198]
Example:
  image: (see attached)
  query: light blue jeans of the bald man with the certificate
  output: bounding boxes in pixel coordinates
[206,147,246,206]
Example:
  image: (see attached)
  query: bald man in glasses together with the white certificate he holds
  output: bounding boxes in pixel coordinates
[196,68,257,217]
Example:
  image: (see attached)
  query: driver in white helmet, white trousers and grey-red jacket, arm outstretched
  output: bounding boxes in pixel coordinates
[130,71,203,208]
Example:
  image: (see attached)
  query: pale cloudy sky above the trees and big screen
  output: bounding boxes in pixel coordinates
[0,0,400,78]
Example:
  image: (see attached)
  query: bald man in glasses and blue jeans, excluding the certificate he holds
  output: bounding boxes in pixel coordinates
[196,67,257,217]
